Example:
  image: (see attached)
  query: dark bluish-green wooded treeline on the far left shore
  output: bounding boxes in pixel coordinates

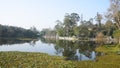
[0,24,39,38]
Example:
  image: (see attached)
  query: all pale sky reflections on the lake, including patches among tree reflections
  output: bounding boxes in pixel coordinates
[0,41,96,60]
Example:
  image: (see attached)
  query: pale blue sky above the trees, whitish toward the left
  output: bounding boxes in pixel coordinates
[0,0,109,30]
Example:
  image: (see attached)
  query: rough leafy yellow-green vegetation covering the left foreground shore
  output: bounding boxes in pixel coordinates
[0,52,74,68]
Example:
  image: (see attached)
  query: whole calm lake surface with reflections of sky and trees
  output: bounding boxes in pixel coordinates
[0,39,98,61]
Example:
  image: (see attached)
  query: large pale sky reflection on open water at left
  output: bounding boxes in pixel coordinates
[0,41,56,55]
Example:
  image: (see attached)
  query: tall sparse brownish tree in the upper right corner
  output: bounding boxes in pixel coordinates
[106,0,120,30]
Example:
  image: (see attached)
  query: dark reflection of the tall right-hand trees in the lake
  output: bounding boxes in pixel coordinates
[42,39,96,60]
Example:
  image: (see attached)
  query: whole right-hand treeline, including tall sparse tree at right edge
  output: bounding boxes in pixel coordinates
[41,0,120,38]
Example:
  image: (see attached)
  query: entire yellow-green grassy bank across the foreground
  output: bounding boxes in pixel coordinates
[0,52,120,68]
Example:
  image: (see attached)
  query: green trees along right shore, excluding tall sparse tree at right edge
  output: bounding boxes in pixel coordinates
[41,13,117,38]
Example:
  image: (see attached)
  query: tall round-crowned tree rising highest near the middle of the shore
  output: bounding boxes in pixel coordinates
[63,13,80,36]
